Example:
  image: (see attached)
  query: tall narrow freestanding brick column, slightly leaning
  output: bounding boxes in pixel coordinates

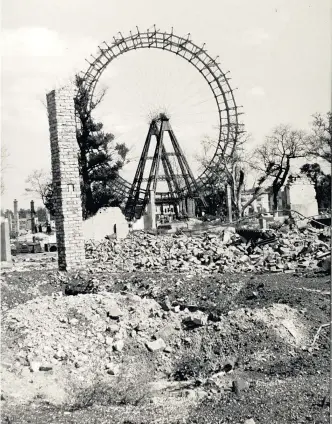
[46,86,85,271]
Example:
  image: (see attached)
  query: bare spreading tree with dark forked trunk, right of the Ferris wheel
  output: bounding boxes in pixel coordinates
[252,125,307,210]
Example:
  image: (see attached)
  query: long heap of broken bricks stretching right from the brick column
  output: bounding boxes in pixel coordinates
[86,226,330,273]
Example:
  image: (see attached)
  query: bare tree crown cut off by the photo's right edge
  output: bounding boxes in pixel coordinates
[308,112,332,163]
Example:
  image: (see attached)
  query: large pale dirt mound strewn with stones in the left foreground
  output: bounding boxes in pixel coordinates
[2,293,180,408]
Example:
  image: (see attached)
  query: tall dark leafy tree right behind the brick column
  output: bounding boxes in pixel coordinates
[75,76,128,218]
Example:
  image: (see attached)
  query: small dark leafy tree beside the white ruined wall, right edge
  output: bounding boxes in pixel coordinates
[300,163,331,209]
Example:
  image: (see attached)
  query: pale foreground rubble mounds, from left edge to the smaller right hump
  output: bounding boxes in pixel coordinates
[2,292,308,408]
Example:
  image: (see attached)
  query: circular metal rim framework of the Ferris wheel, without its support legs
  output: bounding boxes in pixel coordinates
[83,25,243,205]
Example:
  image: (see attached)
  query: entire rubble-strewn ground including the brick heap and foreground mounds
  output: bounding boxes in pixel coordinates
[1,224,330,424]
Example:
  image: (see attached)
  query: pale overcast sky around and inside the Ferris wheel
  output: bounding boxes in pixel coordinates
[1,0,331,208]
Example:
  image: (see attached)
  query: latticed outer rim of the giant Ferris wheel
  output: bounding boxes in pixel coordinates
[83,28,241,199]
